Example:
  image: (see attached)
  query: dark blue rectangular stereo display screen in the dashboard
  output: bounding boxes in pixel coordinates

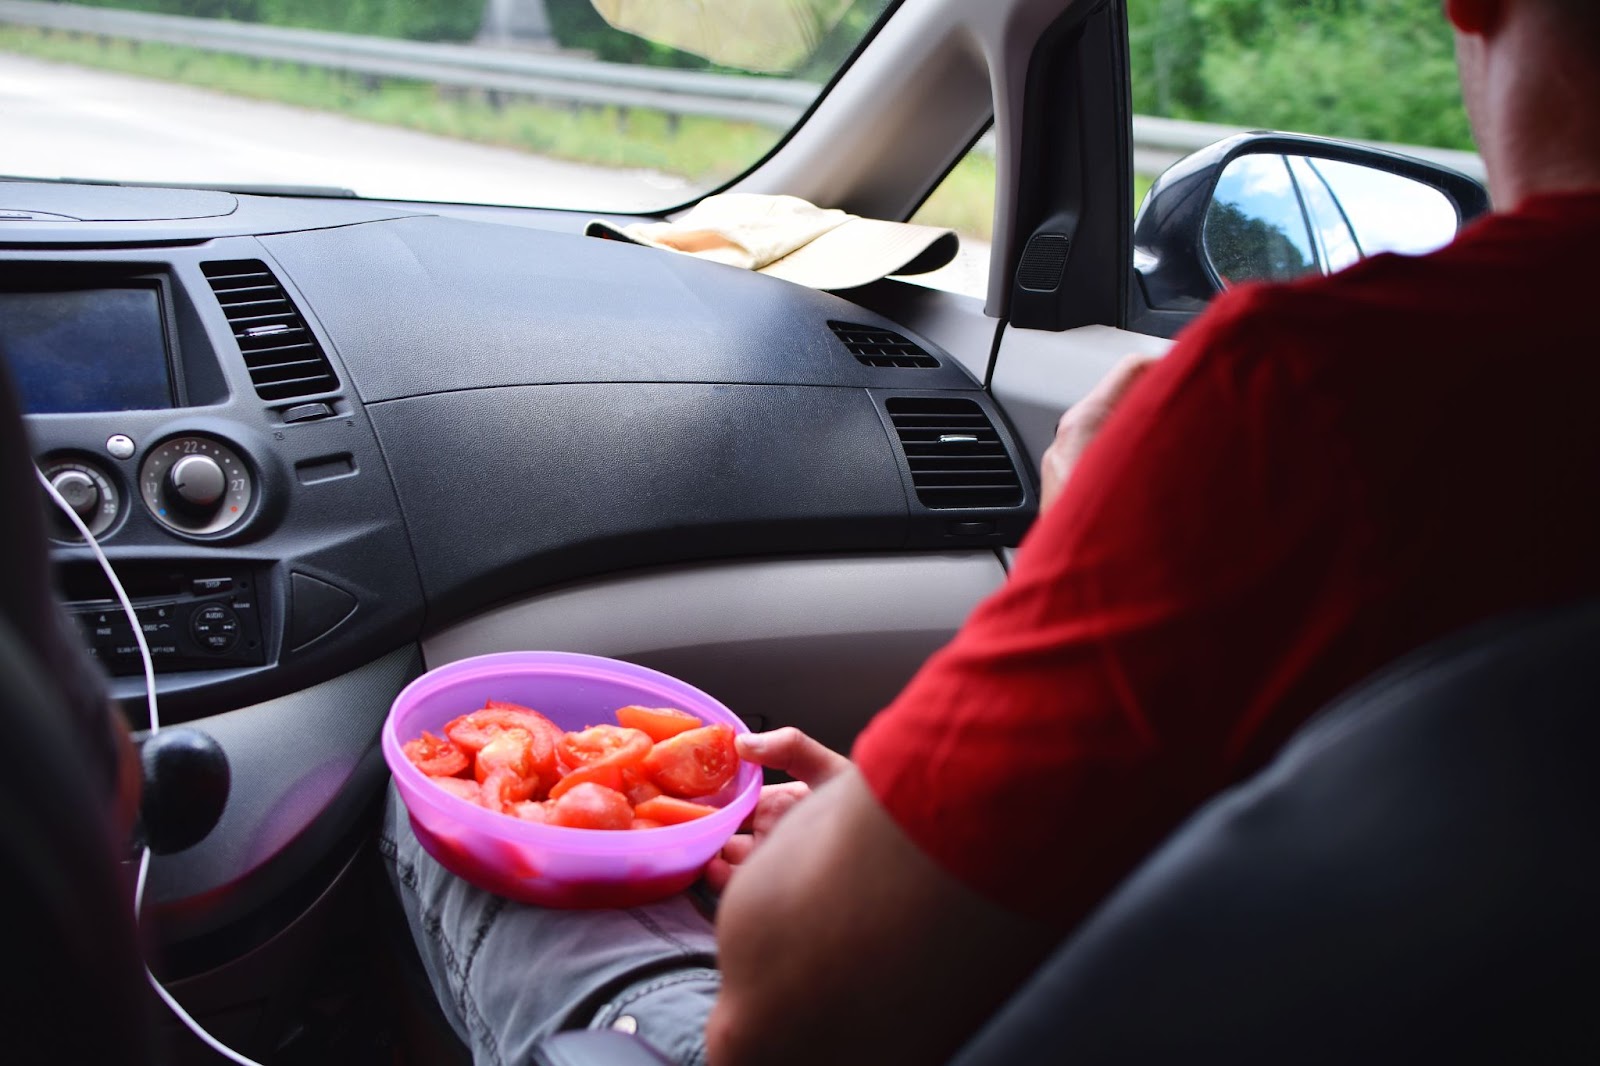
[0,285,173,415]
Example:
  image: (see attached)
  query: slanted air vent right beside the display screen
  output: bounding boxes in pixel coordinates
[200,259,339,400]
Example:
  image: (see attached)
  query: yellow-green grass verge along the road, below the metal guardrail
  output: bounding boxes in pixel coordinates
[0,26,1150,242]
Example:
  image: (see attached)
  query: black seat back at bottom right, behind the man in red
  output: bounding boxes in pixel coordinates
[957,605,1600,1066]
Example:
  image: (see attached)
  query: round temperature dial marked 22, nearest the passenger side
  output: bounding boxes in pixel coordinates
[139,434,256,536]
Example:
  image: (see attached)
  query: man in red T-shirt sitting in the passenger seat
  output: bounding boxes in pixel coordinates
[706,0,1600,1066]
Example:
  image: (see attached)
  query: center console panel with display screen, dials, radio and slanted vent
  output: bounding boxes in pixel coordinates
[0,237,422,720]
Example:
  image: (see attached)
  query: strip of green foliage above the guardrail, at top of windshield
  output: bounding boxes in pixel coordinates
[78,0,485,40]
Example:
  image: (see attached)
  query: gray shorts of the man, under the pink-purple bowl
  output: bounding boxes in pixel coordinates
[379,786,720,1066]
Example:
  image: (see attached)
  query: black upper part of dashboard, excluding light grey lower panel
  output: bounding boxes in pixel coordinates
[0,182,1035,960]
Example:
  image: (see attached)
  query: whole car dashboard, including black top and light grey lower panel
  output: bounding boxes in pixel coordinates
[0,182,1035,972]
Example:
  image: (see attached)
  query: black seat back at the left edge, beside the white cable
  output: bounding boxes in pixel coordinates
[0,365,150,1063]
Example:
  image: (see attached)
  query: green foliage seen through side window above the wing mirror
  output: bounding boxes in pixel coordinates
[1128,0,1472,149]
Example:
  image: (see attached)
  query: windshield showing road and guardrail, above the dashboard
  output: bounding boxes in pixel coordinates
[0,0,891,211]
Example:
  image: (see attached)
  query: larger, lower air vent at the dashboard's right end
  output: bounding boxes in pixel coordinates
[886,395,1022,509]
